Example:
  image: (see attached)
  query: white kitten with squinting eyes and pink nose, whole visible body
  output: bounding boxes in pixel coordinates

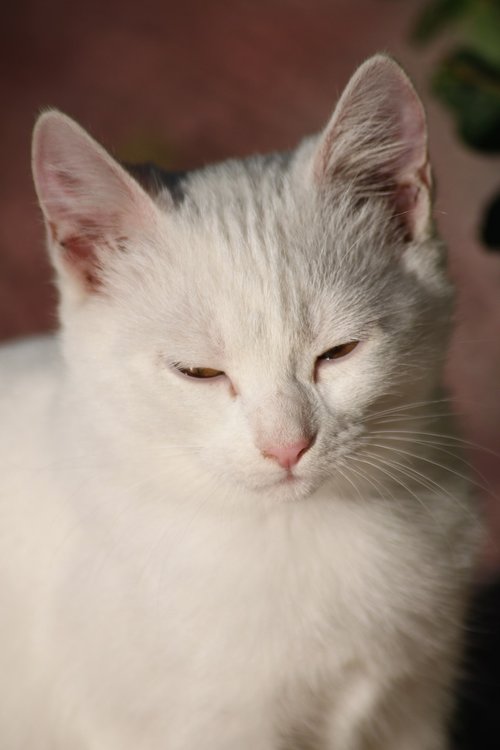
[0,55,479,750]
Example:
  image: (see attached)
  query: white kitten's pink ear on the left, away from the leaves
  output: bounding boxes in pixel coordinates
[32,110,160,298]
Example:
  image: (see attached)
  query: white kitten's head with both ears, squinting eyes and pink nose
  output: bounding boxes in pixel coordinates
[33,55,451,498]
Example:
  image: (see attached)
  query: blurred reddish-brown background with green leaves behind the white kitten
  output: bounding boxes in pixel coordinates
[0,0,500,570]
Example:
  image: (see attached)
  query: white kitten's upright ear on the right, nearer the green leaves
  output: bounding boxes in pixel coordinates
[314,55,431,240]
